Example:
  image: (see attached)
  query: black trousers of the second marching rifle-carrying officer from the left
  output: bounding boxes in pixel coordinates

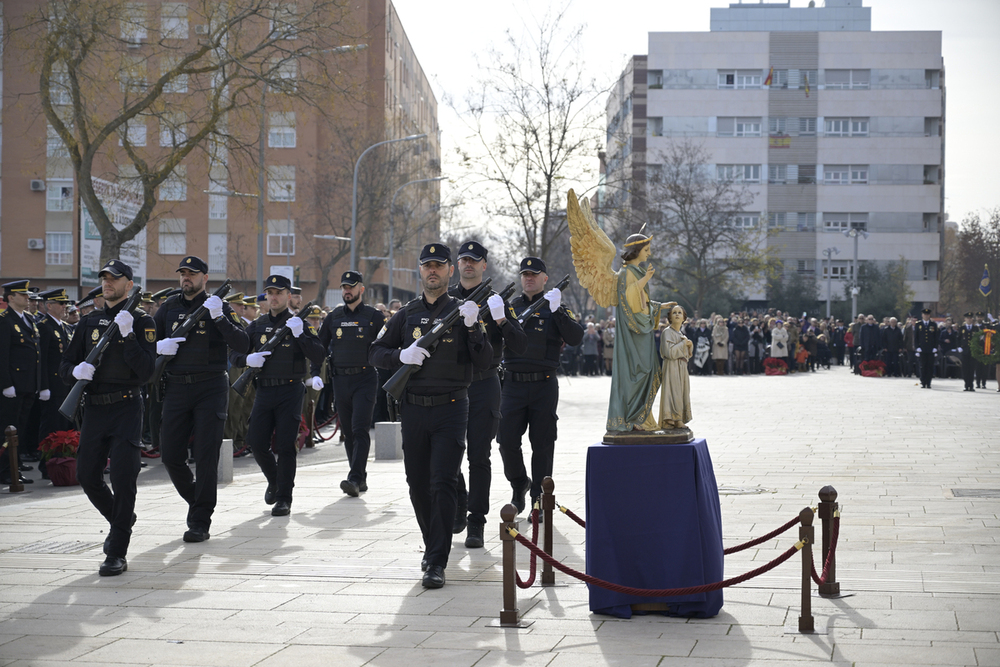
[160,371,229,531]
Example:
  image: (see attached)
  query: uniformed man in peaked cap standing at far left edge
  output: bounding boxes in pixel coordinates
[0,280,42,484]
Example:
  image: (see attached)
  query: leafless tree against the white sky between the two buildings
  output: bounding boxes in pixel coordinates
[449,3,603,257]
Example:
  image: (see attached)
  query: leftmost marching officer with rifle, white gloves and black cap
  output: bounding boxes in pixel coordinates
[59,259,156,576]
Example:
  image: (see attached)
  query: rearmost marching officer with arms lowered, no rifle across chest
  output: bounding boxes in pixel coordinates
[312,271,385,498]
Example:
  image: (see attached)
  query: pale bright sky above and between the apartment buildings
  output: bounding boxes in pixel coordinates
[393,0,1000,227]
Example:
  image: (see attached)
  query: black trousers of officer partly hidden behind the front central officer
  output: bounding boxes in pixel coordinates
[458,374,501,526]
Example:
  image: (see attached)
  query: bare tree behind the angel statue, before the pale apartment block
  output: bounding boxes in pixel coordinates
[647,140,772,313]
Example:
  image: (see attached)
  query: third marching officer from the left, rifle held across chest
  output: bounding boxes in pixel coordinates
[230,275,323,516]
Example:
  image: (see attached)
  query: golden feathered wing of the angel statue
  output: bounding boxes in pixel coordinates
[566,190,618,308]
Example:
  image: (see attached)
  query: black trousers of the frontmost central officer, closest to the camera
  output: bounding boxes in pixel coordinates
[399,396,469,567]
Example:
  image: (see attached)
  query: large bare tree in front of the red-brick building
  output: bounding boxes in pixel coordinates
[12,0,360,262]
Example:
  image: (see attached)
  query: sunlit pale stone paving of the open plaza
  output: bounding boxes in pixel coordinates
[0,367,1000,667]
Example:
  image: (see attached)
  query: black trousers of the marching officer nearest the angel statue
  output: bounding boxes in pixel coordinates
[498,376,560,500]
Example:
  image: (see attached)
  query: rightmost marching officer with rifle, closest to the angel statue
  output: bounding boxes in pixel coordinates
[498,257,583,512]
